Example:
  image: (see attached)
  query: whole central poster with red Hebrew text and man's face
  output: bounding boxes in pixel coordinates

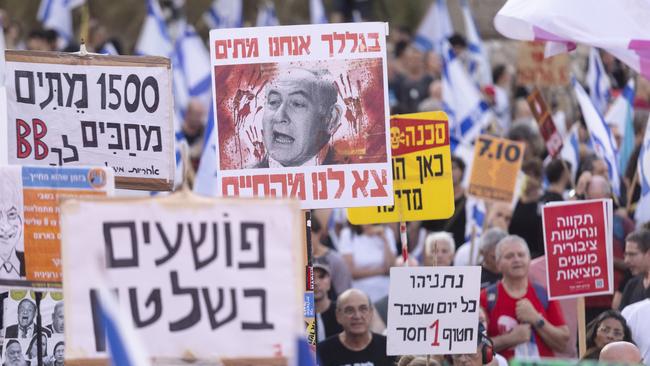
[210,23,393,209]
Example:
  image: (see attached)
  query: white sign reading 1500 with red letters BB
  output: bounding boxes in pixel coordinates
[6,51,176,190]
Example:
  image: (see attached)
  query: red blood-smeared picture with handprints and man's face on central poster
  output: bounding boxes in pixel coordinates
[215,59,386,170]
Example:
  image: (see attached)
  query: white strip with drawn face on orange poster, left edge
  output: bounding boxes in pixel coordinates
[0,169,24,278]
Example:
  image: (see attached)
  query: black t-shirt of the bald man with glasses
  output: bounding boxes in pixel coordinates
[316,333,395,366]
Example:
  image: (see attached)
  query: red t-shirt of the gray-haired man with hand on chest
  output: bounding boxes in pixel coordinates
[481,281,565,359]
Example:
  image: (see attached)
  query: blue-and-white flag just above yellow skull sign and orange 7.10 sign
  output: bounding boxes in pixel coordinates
[442,42,494,144]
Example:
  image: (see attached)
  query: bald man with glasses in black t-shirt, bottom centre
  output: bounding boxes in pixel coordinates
[316,289,395,366]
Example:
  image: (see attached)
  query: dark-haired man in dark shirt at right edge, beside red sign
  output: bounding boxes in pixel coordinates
[619,229,650,310]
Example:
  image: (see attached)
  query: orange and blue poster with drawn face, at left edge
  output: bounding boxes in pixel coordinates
[0,166,114,289]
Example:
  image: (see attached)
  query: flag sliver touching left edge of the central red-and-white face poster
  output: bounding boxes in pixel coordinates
[194,102,219,197]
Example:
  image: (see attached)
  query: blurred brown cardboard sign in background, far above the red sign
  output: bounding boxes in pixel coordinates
[517,42,571,87]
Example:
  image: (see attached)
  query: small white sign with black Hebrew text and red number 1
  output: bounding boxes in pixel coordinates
[386,266,481,355]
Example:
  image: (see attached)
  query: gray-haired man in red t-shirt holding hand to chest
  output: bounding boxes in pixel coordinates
[481,235,569,359]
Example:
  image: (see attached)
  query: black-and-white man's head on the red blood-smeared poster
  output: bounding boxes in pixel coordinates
[262,69,341,166]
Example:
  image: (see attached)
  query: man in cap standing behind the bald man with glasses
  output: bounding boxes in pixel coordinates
[314,258,343,342]
